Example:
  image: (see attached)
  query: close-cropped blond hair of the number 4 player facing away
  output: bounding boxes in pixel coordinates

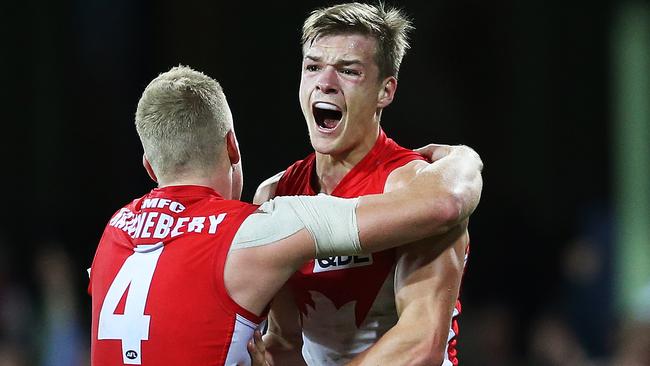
[135,66,232,178]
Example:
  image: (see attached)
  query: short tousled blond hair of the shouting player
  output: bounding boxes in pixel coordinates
[302,2,413,78]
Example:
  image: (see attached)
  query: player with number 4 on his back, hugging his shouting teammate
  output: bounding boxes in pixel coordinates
[88,67,482,366]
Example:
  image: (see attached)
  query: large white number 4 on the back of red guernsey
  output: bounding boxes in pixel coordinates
[97,242,164,365]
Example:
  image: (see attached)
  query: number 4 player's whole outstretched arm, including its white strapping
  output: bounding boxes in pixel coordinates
[224,146,482,314]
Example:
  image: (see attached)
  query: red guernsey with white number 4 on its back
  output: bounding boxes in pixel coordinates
[88,186,262,366]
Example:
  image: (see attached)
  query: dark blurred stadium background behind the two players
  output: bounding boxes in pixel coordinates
[0,0,650,366]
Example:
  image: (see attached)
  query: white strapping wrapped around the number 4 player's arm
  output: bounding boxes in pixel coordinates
[230,195,361,258]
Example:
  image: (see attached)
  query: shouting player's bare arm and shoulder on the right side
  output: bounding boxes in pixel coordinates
[349,161,469,366]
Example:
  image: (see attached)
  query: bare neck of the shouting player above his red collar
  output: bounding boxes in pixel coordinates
[312,129,379,194]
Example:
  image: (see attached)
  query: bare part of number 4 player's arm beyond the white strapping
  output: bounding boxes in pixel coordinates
[357,146,483,251]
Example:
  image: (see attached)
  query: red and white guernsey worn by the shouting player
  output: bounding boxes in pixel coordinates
[276,131,460,366]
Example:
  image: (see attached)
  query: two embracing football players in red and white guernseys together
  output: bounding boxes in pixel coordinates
[89,3,482,366]
